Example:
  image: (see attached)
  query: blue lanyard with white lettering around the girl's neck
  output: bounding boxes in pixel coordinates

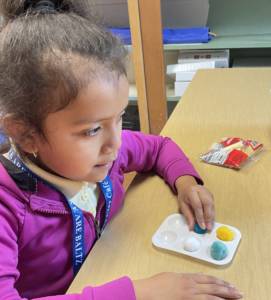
[9,150,113,275]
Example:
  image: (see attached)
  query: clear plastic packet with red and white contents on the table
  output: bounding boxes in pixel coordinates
[200,137,263,169]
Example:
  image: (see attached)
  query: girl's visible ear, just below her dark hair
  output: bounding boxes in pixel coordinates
[2,115,37,153]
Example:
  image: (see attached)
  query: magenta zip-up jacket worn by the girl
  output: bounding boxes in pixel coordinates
[0,131,201,300]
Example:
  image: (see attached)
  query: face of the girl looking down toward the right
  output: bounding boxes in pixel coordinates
[32,76,129,182]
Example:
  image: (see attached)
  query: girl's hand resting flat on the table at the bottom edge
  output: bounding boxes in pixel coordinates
[133,273,242,300]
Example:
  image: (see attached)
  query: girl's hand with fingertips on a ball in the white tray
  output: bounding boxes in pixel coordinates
[175,176,215,231]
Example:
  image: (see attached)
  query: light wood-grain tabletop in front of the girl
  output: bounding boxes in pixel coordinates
[68,68,271,300]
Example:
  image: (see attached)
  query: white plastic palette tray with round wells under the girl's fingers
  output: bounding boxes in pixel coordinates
[152,214,241,266]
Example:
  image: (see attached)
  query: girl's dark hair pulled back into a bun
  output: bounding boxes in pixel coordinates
[0,0,127,150]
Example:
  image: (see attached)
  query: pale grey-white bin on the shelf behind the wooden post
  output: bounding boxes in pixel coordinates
[92,0,209,27]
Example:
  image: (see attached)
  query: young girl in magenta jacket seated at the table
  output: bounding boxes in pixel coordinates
[0,0,244,300]
